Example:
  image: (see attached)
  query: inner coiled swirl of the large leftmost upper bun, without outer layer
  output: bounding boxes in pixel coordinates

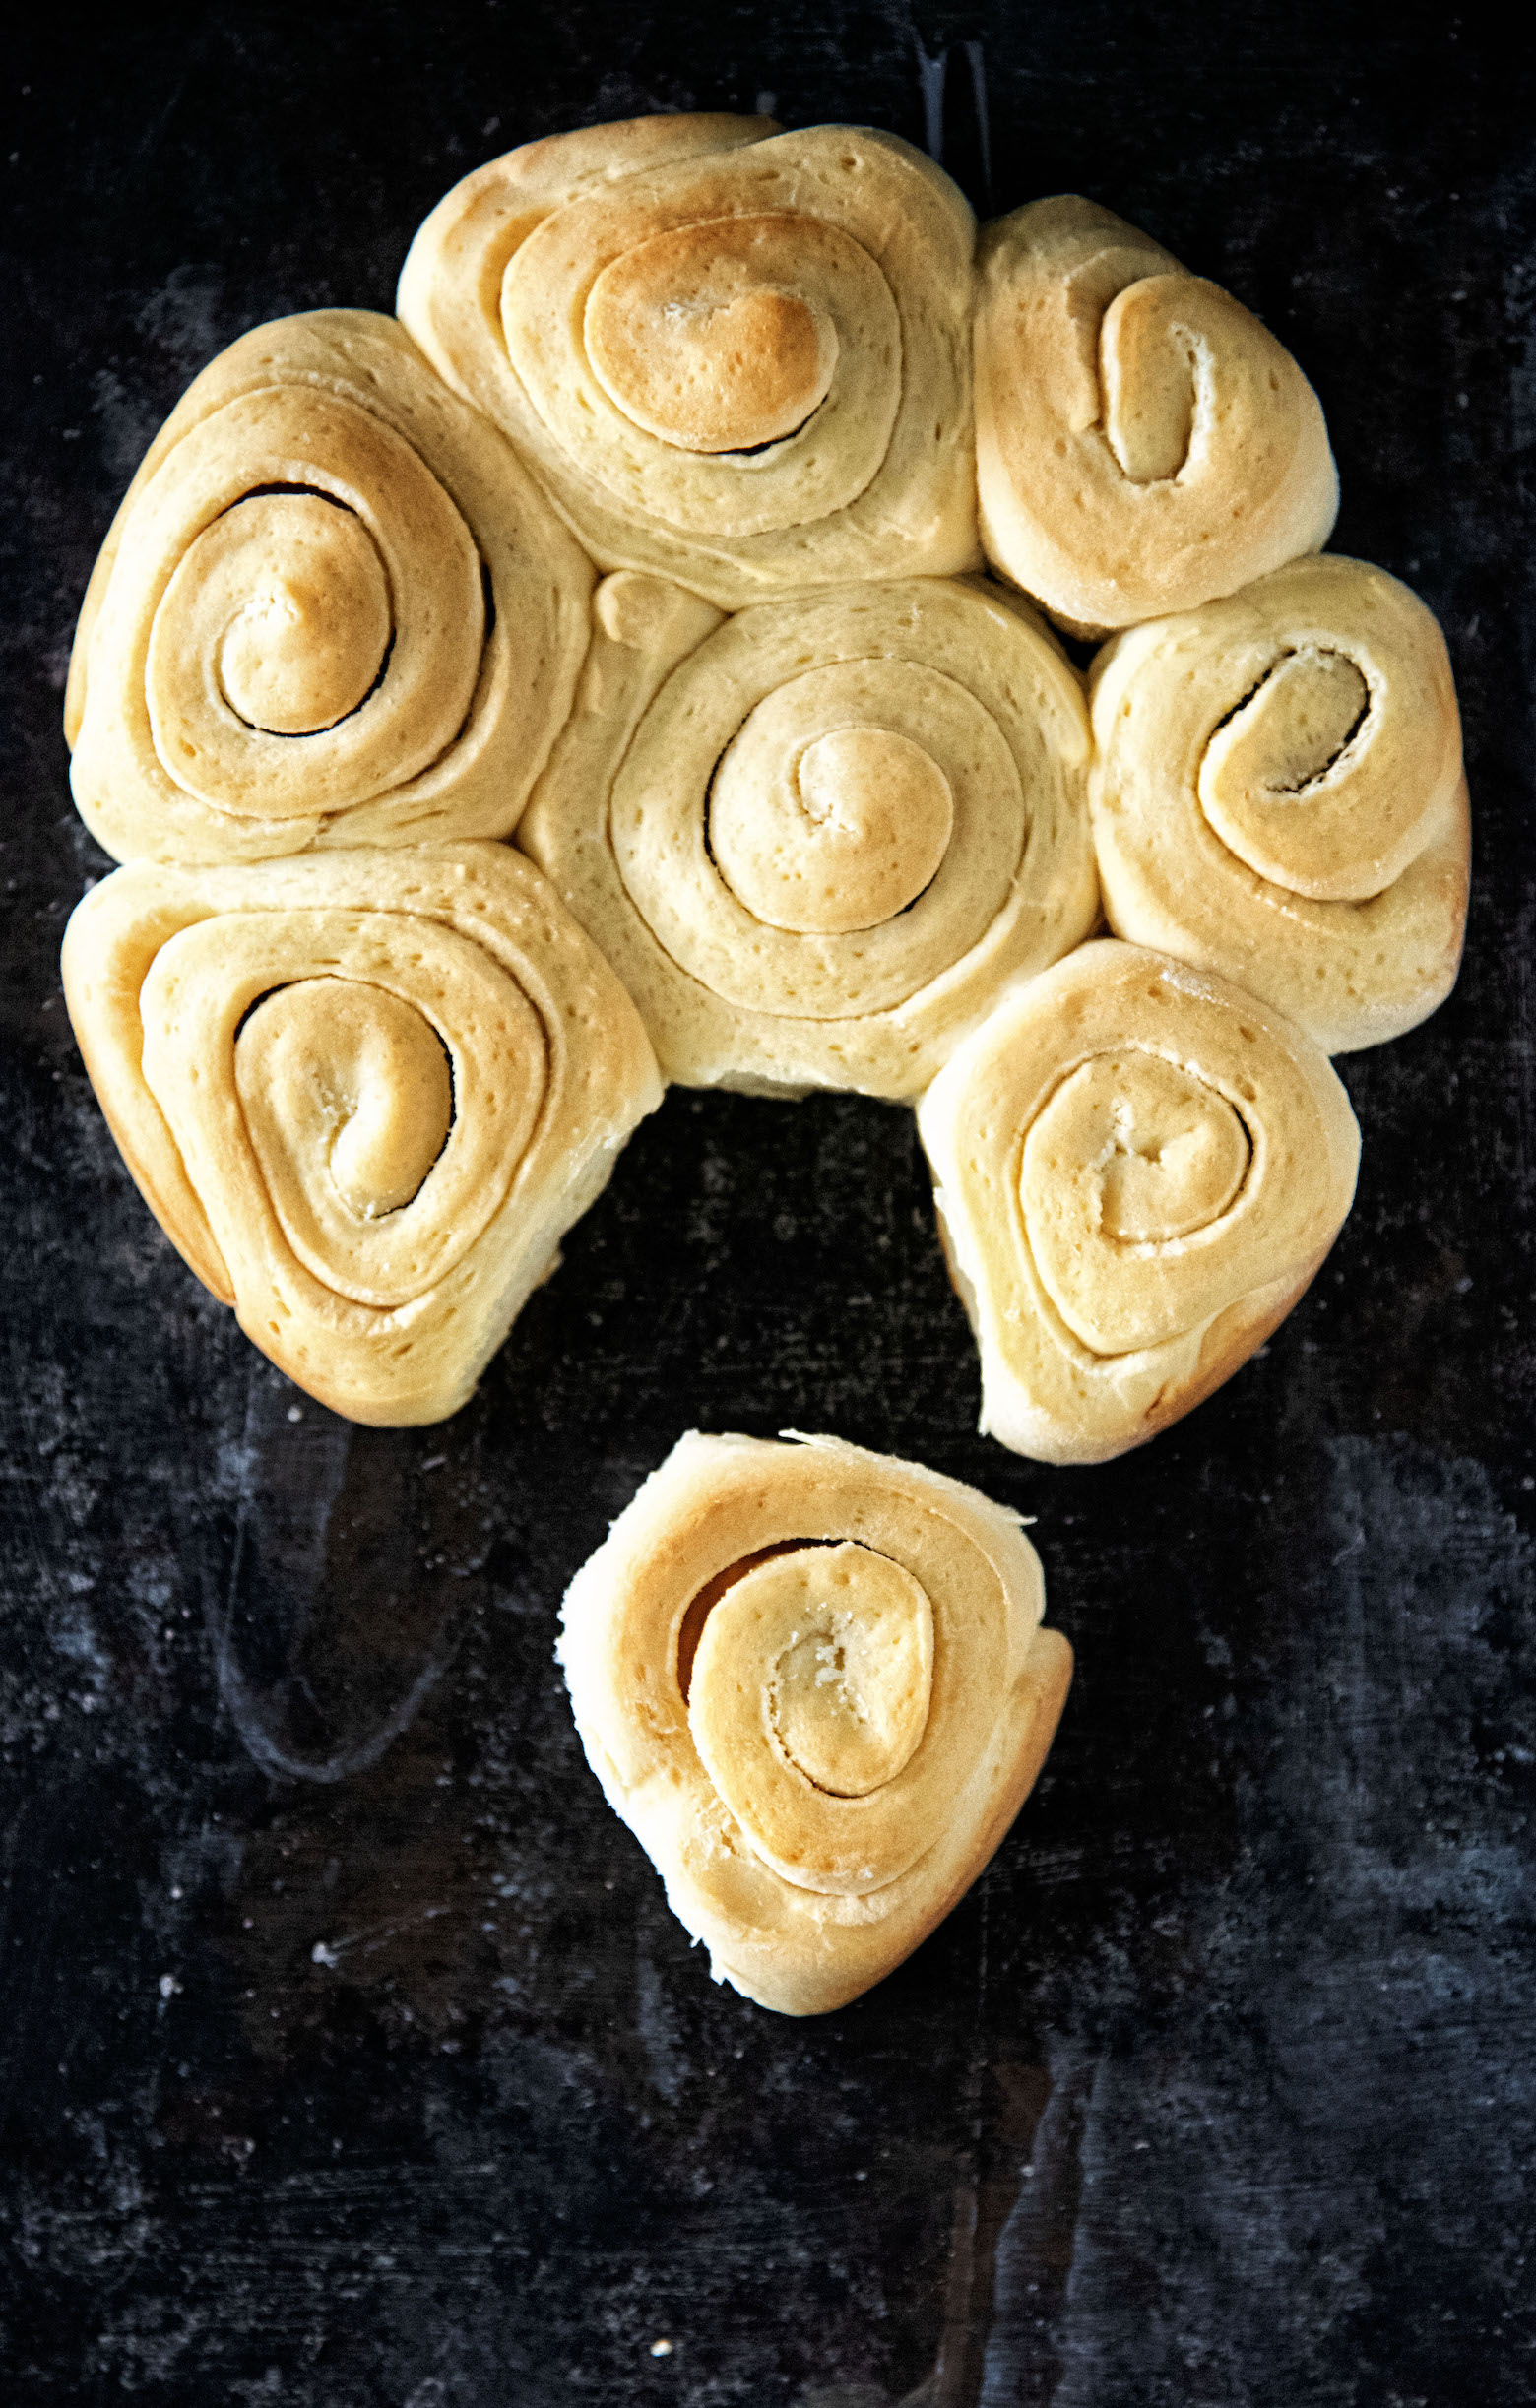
[143,385,486,819]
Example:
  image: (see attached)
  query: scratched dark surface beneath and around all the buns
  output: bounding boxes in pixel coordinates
[0,0,1536,2408]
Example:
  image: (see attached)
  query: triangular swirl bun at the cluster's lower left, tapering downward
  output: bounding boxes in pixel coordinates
[63,843,662,1424]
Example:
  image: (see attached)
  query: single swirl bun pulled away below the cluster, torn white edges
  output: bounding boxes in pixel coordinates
[558,1430,1071,2015]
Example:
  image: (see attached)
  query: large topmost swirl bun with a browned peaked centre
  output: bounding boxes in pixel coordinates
[397,115,980,609]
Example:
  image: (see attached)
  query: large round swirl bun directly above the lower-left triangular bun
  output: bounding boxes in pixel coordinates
[65,311,593,862]
